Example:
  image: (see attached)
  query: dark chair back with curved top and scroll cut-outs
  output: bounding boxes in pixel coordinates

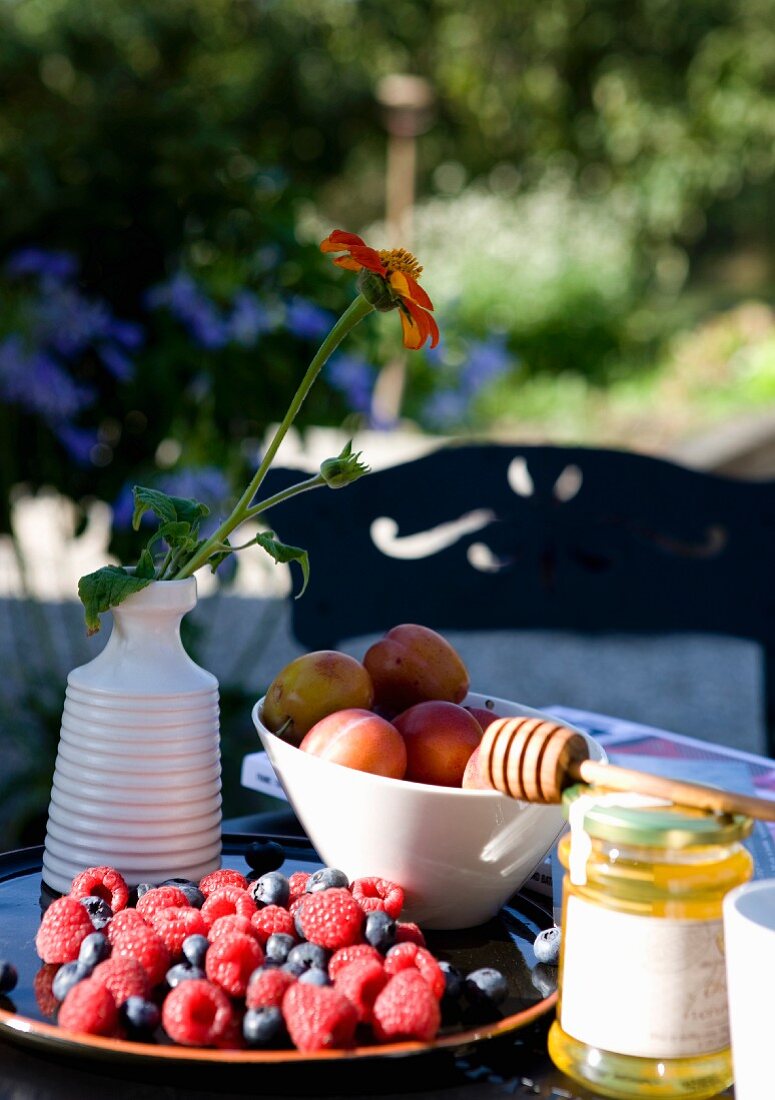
[262,443,775,754]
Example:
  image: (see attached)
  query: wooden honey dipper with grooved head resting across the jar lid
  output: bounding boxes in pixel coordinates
[479,717,775,821]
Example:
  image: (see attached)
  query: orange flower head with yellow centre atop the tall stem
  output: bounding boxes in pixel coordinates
[320,229,439,349]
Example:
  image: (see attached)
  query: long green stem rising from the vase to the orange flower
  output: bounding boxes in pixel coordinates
[173,295,374,581]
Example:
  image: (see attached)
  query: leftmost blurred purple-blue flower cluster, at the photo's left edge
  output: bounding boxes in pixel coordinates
[0,248,143,465]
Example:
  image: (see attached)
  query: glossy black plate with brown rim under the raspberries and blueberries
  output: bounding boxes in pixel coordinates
[0,835,557,1068]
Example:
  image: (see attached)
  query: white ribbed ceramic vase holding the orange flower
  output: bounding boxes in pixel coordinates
[43,578,221,893]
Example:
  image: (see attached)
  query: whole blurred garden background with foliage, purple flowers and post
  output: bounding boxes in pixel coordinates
[0,0,775,846]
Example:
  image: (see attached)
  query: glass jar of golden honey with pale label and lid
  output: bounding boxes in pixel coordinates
[549,784,753,1100]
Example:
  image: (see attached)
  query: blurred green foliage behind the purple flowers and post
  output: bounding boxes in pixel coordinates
[0,0,775,523]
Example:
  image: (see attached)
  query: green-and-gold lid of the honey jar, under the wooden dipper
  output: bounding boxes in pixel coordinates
[563,783,753,848]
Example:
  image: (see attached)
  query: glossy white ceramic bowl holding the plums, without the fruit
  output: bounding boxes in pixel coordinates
[253,692,606,928]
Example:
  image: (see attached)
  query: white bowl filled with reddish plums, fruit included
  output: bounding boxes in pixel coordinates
[253,624,606,930]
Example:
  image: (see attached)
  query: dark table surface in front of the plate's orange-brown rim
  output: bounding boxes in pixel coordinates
[0,834,733,1100]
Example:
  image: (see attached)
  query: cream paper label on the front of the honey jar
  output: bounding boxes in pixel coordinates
[560,895,729,1058]
